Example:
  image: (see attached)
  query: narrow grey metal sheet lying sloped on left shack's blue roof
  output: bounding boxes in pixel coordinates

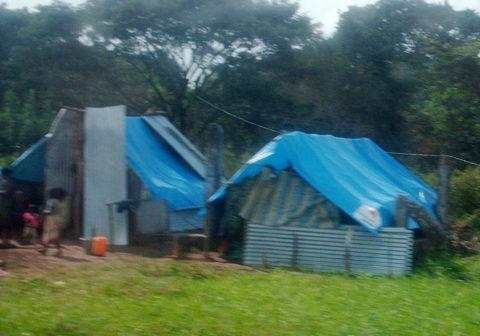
[142,115,207,179]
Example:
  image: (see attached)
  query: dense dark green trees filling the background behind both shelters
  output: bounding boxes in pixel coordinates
[0,0,480,220]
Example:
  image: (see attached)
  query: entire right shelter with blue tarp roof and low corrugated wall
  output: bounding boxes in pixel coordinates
[208,132,437,275]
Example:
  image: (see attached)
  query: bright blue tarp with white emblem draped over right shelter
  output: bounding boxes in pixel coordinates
[208,132,438,232]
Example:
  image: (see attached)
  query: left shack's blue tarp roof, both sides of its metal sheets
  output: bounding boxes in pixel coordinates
[12,117,205,209]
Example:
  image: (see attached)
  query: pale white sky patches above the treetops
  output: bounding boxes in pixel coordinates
[0,0,480,37]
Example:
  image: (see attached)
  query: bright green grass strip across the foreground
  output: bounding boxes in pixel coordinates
[0,258,480,336]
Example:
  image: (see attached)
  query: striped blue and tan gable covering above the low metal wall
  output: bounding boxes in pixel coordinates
[239,168,339,229]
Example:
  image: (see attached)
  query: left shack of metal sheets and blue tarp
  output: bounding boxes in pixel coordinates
[12,106,206,245]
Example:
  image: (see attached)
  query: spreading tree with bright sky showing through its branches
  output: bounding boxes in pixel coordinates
[86,0,316,131]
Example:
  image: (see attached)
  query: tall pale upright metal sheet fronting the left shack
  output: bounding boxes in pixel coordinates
[83,106,128,245]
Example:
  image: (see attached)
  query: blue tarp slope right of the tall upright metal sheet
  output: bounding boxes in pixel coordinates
[126,117,205,209]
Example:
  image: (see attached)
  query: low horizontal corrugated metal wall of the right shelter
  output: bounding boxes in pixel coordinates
[243,223,413,275]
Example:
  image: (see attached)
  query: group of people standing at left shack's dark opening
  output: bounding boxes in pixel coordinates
[0,168,71,256]
